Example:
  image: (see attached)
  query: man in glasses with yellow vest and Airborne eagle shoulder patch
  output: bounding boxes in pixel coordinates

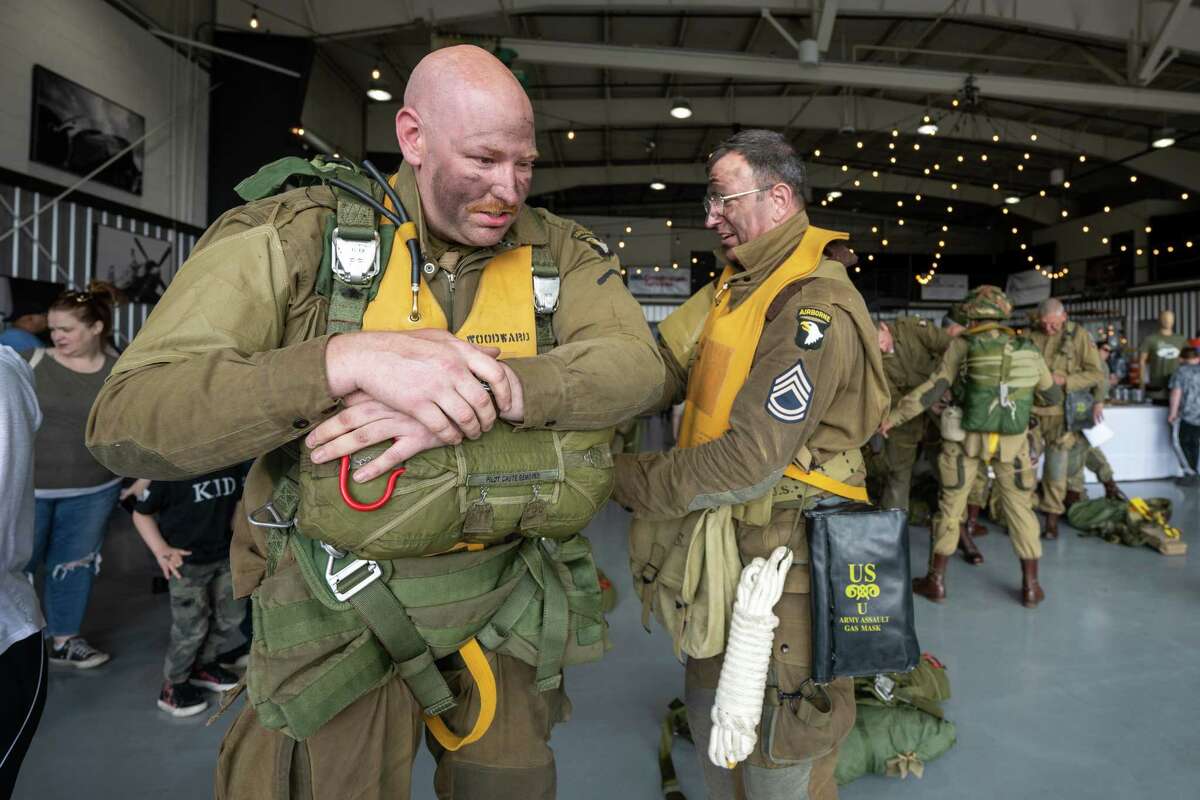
[613,130,888,800]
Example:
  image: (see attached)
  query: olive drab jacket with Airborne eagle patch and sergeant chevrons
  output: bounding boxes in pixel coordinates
[613,211,888,519]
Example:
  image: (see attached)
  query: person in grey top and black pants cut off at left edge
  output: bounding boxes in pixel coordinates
[0,345,46,798]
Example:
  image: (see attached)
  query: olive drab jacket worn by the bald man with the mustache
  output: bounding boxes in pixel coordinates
[88,166,664,596]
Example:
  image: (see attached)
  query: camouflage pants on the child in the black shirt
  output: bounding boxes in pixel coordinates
[162,559,246,684]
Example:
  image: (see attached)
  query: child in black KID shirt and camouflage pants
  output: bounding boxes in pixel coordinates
[133,465,246,717]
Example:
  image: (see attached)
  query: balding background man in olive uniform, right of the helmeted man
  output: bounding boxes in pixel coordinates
[1030,297,1108,539]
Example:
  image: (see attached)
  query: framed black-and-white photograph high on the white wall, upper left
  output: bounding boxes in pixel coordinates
[29,65,146,194]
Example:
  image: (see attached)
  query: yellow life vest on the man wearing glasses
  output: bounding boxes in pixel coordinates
[679,225,868,503]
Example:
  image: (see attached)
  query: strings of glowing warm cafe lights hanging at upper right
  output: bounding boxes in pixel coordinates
[811,97,1195,285]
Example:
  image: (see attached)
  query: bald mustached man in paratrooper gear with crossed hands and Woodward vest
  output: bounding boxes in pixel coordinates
[89,47,662,800]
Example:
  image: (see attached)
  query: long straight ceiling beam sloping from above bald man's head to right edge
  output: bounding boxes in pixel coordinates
[500,37,1200,114]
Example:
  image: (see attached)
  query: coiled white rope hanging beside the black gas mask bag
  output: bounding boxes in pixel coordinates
[708,547,792,769]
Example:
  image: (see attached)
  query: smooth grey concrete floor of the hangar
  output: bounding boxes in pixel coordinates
[14,481,1200,800]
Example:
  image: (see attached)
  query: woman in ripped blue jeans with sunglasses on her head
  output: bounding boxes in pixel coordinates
[28,283,121,669]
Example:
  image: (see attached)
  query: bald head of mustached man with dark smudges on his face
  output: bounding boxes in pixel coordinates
[396,44,538,247]
